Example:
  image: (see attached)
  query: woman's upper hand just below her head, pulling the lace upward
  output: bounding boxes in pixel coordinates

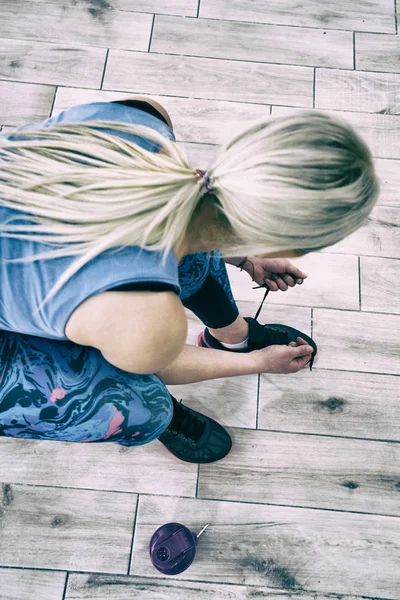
[241,256,307,292]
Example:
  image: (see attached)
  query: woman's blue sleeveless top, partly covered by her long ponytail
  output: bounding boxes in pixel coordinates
[0,102,180,340]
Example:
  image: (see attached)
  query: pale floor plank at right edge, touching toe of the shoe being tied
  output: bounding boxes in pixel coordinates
[313,308,400,375]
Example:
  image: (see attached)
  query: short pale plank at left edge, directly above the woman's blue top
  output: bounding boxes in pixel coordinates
[0,81,55,125]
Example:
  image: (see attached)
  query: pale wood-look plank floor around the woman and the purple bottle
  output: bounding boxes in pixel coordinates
[0,0,400,600]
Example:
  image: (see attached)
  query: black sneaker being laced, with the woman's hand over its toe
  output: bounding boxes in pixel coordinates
[196,317,317,371]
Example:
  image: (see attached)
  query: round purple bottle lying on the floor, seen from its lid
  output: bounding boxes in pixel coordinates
[150,523,207,575]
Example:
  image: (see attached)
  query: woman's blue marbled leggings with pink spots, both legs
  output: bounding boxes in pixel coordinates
[0,252,239,446]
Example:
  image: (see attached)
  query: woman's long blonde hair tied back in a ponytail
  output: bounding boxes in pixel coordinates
[0,111,379,306]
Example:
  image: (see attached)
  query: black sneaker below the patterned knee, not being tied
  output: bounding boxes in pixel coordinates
[158,396,232,463]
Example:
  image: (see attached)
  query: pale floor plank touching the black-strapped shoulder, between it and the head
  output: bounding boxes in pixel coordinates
[53,88,270,144]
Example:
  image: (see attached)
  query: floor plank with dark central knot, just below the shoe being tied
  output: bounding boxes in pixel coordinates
[258,368,400,441]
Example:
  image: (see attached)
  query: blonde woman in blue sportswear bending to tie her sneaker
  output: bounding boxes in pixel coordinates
[0,99,378,463]
